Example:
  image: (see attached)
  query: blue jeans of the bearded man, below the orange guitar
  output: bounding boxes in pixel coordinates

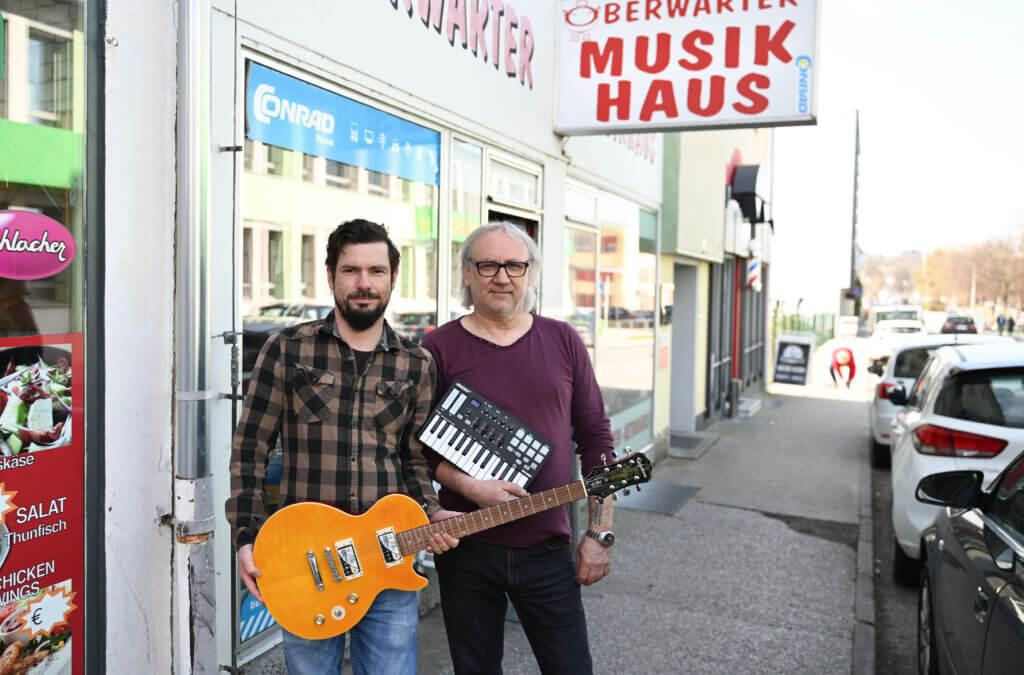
[281,589,420,675]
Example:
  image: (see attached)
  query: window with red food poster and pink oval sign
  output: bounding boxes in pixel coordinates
[0,0,88,673]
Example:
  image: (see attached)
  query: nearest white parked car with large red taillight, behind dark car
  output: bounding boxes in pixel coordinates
[889,342,1024,585]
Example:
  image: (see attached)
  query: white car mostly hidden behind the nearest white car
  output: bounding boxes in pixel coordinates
[867,333,1011,467]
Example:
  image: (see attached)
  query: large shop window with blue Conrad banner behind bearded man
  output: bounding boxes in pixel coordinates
[242,62,440,350]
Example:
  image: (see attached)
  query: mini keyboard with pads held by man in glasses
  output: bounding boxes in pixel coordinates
[418,381,552,488]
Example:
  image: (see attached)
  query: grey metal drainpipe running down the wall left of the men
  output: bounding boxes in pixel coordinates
[168,0,218,675]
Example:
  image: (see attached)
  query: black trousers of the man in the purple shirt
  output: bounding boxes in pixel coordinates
[434,539,593,675]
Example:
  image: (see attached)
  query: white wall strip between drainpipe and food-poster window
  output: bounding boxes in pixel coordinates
[103,0,177,673]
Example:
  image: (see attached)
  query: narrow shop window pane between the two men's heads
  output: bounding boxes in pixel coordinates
[449,140,483,319]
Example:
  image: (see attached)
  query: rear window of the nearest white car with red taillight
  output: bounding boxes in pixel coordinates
[935,368,1024,428]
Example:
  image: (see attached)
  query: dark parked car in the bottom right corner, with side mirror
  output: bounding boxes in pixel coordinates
[918,454,1024,675]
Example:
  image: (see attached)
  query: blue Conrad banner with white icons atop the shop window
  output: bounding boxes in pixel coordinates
[246,62,441,185]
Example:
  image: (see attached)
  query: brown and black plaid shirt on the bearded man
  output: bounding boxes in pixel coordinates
[224,312,439,548]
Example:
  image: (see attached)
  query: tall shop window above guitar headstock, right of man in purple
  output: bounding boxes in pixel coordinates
[596,194,656,452]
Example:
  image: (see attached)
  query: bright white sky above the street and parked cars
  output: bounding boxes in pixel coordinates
[772,0,1024,304]
